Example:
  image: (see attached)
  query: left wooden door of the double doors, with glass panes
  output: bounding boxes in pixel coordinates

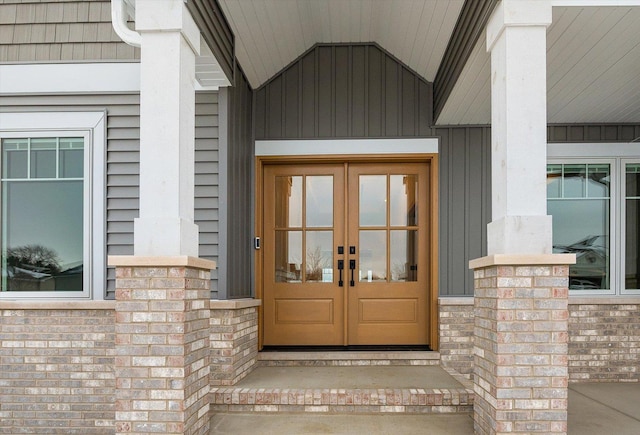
[263,164,345,345]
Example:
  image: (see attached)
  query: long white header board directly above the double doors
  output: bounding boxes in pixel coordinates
[256,138,438,156]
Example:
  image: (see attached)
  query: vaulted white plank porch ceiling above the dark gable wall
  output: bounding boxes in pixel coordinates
[219,0,464,88]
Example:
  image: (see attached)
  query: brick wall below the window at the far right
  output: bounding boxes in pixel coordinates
[569,298,640,382]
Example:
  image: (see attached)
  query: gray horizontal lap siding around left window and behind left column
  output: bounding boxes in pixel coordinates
[0,93,219,299]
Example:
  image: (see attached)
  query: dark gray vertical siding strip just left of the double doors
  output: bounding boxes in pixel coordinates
[218,70,254,299]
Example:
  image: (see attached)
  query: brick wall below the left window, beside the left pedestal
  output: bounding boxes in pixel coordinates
[0,302,115,434]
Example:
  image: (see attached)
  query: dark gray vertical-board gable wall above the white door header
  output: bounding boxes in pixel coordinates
[255,44,432,139]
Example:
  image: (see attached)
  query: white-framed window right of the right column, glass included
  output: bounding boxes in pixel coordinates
[547,144,640,295]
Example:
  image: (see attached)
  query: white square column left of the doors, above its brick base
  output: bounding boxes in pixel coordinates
[134,0,200,257]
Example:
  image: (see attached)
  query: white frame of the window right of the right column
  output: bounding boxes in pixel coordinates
[547,142,640,296]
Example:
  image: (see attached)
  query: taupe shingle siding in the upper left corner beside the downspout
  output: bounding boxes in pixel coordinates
[0,0,140,62]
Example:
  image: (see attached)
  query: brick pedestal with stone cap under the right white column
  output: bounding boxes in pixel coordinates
[470,254,575,434]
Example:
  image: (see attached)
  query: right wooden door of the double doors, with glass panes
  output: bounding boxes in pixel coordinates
[347,163,430,345]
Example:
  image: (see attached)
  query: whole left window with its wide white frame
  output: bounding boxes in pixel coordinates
[0,112,105,299]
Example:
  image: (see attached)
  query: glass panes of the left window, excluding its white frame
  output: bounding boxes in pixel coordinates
[1,138,84,292]
